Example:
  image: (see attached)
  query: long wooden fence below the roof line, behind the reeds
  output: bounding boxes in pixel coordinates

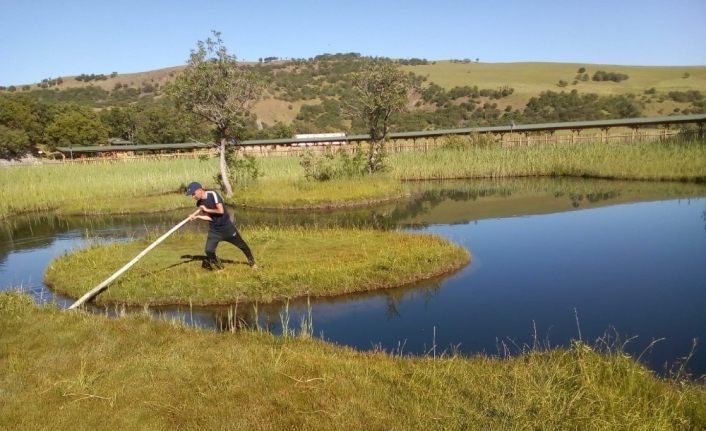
[56,114,706,162]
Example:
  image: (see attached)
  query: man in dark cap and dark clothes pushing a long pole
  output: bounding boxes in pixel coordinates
[186,182,257,269]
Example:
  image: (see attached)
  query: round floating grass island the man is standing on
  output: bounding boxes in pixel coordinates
[45,228,470,305]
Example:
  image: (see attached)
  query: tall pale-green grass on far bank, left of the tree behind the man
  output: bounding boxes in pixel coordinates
[0,159,217,216]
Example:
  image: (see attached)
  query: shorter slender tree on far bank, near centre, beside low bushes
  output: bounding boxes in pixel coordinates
[349,60,411,174]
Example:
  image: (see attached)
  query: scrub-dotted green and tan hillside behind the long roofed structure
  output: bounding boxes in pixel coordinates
[0,53,706,157]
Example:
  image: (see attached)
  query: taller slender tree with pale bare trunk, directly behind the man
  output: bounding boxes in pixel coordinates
[167,31,263,197]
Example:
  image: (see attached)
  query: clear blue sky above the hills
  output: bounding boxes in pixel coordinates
[0,0,706,85]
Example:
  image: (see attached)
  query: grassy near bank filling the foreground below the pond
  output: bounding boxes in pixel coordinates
[0,293,706,430]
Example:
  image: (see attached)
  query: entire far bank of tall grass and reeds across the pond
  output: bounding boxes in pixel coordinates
[0,141,706,218]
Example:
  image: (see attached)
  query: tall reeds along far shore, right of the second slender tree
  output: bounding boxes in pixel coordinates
[391,137,706,181]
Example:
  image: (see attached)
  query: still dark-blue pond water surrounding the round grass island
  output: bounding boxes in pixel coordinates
[0,179,706,376]
